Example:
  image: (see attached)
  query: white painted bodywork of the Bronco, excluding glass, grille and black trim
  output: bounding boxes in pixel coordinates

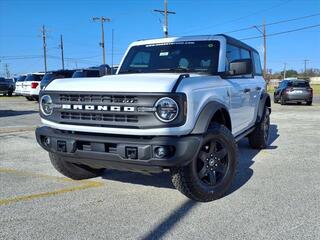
[42,36,265,136]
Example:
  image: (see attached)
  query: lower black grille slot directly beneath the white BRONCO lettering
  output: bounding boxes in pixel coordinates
[61,112,138,123]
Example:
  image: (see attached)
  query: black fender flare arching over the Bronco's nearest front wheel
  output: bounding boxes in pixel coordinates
[191,101,231,134]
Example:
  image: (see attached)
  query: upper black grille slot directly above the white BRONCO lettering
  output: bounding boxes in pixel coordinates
[60,94,137,103]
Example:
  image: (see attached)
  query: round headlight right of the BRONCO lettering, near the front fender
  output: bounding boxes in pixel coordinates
[155,97,179,122]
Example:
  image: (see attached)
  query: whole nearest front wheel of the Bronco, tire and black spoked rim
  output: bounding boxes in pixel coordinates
[171,123,237,202]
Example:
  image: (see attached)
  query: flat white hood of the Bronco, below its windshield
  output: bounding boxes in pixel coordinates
[45,73,199,92]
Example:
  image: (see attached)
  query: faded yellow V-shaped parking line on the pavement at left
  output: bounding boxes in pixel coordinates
[0,168,104,206]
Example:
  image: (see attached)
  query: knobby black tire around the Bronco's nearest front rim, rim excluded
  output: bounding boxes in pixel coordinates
[171,123,238,202]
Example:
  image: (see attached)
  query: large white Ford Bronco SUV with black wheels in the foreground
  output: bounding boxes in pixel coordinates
[36,35,271,201]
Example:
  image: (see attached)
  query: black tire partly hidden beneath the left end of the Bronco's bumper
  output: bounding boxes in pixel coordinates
[49,153,104,180]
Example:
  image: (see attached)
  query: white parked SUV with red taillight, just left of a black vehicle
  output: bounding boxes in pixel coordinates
[21,73,44,101]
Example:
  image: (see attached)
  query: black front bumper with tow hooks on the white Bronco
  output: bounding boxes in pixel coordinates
[36,127,202,172]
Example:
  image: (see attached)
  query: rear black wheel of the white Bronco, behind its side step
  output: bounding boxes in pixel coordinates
[249,107,270,149]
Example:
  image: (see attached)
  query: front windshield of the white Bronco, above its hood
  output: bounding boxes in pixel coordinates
[119,41,220,74]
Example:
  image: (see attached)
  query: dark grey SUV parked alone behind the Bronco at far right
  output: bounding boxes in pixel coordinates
[273,79,313,105]
